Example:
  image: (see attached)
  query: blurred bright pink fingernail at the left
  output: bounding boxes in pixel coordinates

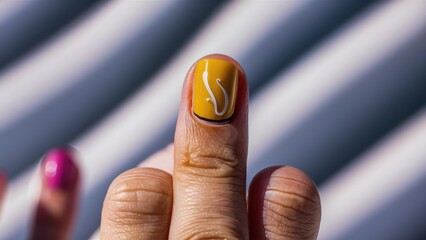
[42,148,78,189]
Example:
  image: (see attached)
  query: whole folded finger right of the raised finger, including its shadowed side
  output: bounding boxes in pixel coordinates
[248,167,321,240]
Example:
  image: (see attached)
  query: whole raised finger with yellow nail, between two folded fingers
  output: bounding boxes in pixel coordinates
[170,55,248,239]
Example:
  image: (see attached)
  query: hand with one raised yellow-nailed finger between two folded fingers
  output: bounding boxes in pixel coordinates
[100,55,321,239]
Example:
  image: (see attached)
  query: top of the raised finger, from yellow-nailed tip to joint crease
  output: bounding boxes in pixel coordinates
[174,54,248,174]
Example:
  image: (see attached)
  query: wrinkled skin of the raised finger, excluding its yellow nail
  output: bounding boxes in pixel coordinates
[170,56,248,239]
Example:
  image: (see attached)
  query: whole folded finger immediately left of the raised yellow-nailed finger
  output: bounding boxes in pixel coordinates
[100,168,173,240]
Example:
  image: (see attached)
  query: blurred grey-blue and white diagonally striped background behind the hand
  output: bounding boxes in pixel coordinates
[0,0,426,240]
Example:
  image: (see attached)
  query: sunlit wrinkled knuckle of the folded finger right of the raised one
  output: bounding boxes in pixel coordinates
[264,167,321,239]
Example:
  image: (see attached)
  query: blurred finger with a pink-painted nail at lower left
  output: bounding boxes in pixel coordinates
[31,148,80,239]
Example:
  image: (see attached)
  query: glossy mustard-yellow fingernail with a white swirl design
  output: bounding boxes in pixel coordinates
[192,59,238,122]
